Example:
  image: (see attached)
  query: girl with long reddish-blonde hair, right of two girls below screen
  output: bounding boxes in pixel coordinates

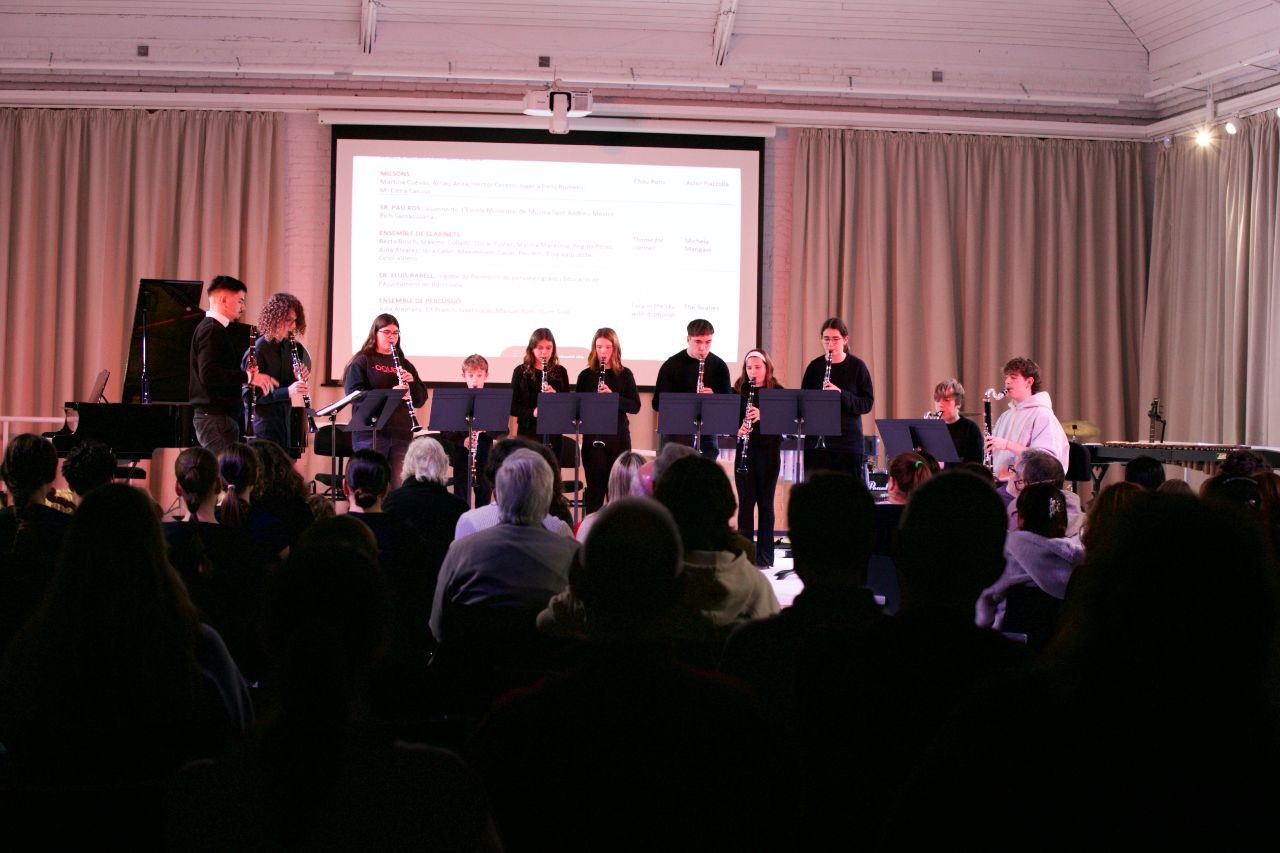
[576,327,640,515]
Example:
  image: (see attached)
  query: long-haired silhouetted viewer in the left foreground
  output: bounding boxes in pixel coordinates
[0,484,253,784]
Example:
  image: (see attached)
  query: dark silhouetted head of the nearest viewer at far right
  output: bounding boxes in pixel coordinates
[1060,493,1276,696]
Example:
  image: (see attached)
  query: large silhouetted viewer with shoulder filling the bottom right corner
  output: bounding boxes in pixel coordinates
[888,493,1277,850]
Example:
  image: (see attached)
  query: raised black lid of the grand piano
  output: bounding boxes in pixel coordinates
[120,278,205,403]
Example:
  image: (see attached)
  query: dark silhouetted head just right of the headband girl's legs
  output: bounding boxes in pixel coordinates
[787,471,876,587]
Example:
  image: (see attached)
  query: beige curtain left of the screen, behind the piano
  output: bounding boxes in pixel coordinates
[0,109,284,432]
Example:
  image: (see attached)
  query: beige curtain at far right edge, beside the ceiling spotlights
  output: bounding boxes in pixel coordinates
[1140,111,1280,446]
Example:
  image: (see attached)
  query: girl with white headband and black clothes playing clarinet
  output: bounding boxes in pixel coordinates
[733,350,782,567]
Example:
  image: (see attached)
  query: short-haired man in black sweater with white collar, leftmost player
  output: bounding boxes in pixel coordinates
[187,275,279,453]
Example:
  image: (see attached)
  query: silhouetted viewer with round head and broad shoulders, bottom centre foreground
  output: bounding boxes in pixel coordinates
[472,499,791,850]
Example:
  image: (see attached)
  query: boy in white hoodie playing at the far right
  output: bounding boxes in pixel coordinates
[987,357,1070,480]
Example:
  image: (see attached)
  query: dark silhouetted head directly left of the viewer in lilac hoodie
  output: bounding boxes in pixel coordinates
[893,469,1009,604]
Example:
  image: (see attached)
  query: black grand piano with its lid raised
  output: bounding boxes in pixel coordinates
[45,278,307,461]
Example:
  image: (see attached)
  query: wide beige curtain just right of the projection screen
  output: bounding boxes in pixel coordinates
[782,129,1146,439]
